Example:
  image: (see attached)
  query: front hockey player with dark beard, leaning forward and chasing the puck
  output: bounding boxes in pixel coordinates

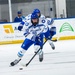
[10,13,45,66]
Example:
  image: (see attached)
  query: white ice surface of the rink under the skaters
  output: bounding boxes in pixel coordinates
[0,40,75,75]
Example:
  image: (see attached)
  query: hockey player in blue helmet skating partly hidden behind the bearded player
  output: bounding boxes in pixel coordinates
[33,9,56,50]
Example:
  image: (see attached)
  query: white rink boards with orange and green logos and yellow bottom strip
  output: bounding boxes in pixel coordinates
[0,18,75,45]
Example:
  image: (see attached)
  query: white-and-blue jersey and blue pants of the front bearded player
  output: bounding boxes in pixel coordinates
[18,20,45,50]
